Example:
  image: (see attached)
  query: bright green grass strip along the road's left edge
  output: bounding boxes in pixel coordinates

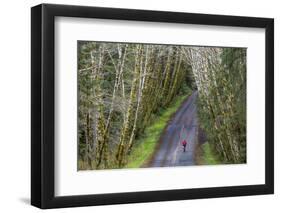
[125,90,192,168]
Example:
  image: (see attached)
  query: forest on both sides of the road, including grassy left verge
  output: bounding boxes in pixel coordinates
[77,41,246,170]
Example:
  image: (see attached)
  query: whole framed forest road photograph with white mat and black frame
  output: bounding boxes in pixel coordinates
[31,4,274,208]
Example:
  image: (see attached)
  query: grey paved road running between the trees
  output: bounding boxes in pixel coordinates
[149,91,198,167]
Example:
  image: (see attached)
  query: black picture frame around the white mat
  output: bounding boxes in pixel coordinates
[31,4,274,209]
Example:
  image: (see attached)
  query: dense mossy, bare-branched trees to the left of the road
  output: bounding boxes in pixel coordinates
[78,42,191,169]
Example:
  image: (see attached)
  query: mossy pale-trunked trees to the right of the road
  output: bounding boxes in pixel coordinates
[187,47,246,163]
